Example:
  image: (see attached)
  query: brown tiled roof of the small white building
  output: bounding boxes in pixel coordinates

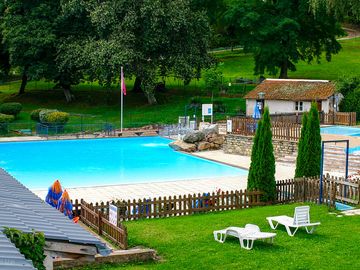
[245,79,335,101]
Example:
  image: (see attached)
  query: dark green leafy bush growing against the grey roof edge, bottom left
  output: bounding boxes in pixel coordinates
[4,228,46,270]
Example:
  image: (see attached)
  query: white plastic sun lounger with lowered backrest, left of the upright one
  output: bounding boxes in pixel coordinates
[214,224,276,250]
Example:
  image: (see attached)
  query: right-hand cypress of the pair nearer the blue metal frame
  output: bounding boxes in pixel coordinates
[303,102,321,177]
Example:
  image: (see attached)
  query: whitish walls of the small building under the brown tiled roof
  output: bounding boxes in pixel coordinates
[246,99,329,117]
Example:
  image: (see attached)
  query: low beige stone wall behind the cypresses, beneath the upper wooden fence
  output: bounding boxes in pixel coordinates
[223,134,297,159]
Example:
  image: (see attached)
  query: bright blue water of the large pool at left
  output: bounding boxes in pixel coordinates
[0,137,247,189]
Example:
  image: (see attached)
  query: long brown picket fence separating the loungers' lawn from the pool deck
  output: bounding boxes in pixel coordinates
[73,175,360,239]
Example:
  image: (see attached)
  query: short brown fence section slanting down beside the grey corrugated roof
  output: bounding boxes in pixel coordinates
[77,200,128,249]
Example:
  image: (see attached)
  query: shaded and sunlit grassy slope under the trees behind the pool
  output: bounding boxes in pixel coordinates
[0,39,360,129]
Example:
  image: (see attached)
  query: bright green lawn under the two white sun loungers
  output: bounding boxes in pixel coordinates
[74,204,360,269]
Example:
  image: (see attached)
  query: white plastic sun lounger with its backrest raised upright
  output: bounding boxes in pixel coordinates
[266,206,320,236]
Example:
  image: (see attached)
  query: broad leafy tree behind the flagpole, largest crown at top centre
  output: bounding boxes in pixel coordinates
[59,0,210,104]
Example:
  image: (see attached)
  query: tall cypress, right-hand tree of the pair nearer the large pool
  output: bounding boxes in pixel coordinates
[256,107,276,201]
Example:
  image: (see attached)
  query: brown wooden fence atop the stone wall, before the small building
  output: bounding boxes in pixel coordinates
[230,117,301,141]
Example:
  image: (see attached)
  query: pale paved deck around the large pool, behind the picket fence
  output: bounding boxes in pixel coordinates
[33,150,295,202]
